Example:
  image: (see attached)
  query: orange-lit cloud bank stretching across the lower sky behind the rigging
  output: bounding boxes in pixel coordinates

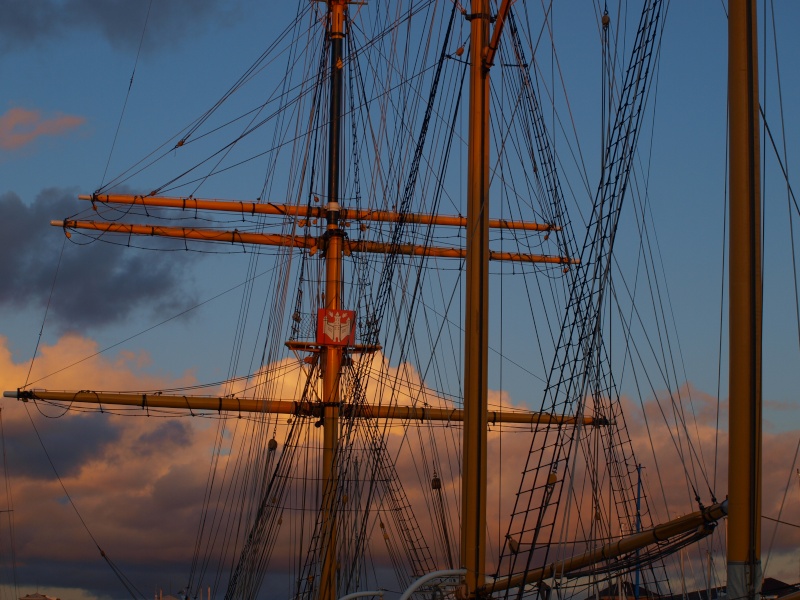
[0,335,800,597]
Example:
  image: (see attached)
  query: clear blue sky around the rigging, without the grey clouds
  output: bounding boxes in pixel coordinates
[0,2,798,406]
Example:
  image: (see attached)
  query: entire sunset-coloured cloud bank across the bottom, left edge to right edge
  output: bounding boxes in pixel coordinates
[0,335,800,597]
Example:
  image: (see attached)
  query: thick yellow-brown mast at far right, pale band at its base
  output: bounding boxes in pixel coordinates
[727,0,761,600]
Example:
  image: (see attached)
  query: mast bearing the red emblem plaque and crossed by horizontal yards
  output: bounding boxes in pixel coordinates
[319,0,346,600]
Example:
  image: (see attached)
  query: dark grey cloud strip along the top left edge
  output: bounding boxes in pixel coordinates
[0,0,244,51]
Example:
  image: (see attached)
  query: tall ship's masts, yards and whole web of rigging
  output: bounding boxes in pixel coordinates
[5,0,784,600]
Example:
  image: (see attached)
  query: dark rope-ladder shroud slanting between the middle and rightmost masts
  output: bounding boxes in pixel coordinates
[504,2,661,593]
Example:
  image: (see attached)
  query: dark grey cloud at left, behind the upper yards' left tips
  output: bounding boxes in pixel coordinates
[0,188,197,332]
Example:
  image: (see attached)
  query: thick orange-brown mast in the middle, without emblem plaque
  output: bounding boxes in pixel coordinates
[461,0,490,596]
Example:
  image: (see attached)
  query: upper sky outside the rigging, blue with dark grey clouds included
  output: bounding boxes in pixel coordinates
[0,0,800,596]
